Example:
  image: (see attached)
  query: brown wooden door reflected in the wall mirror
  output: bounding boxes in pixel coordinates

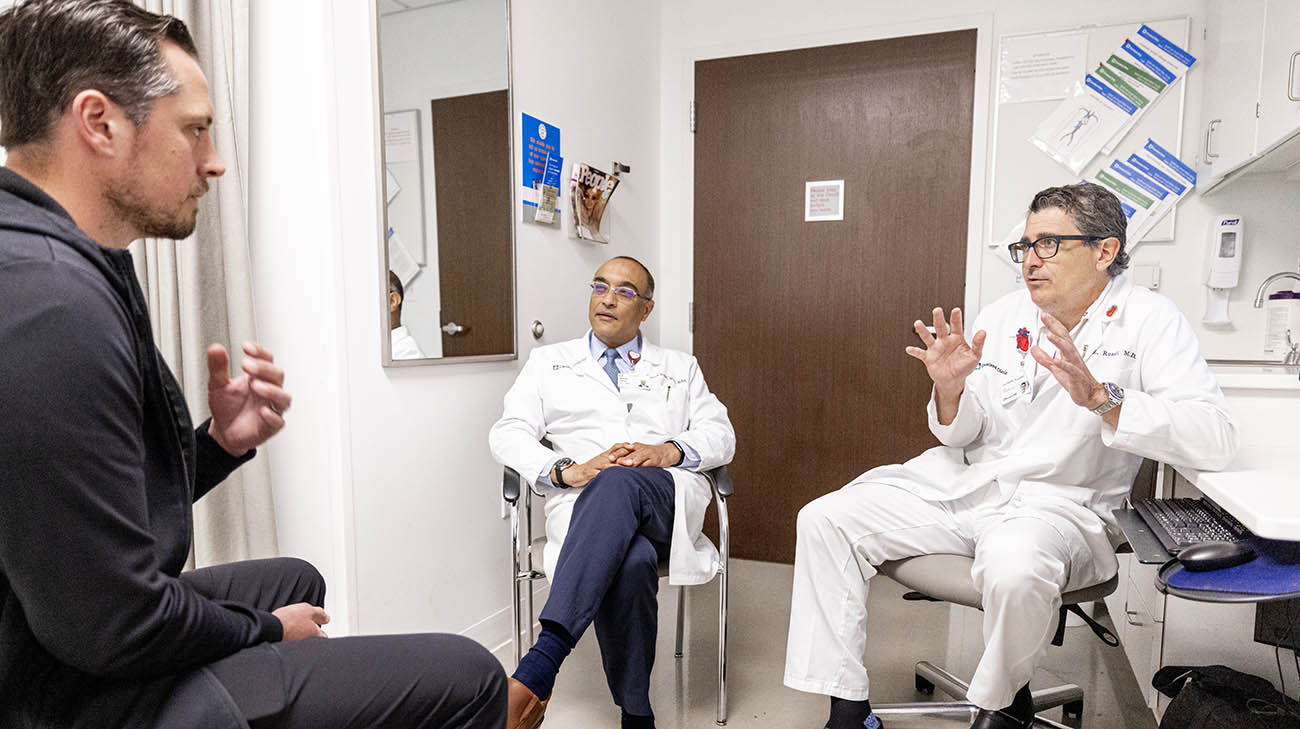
[430,90,515,357]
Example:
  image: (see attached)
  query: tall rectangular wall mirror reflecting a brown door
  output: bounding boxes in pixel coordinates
[378,0,515,366]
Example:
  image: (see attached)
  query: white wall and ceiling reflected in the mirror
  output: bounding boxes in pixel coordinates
[380,0,510,357]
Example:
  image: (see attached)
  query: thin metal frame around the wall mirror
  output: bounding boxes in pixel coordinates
[371,0,519,368]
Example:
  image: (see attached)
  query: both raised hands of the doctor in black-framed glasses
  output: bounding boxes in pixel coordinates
[906,308,1106,409]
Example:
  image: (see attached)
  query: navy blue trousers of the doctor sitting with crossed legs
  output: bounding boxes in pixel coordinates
[540,467,675,716]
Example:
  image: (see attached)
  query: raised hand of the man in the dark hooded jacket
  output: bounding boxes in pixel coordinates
[208,342,293,456]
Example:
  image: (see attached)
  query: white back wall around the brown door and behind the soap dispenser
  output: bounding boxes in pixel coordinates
[660,0,1300,359]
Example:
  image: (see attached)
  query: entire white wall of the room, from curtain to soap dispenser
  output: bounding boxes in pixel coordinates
[251,0,1297,654]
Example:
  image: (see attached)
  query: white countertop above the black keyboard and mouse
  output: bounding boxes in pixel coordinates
[1175,441,1300,539]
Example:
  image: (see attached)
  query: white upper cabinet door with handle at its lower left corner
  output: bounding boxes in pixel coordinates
[1200,0,1268,185]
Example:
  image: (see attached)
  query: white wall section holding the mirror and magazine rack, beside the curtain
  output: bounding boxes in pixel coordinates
[252,0,659,647]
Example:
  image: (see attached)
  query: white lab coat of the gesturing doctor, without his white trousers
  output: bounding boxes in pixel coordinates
[854,274,1238,581]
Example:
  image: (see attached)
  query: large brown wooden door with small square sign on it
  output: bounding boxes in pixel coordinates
[694,30,975,563]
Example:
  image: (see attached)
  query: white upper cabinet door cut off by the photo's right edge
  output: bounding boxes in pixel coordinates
[1234,0,1300,155]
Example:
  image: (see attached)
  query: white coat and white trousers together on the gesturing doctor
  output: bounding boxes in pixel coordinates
[785,275,1238,708]
